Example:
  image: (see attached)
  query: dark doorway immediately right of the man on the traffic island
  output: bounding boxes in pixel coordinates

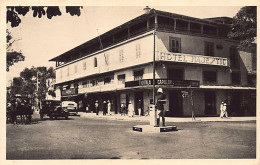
[169,91,183,117]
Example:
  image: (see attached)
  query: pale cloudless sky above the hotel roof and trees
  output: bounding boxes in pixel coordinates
[7,6,241,81]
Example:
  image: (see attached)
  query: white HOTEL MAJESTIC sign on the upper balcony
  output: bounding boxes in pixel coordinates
[158,52,229,66]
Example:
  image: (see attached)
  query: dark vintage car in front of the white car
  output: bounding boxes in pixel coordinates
[40,100,69,119]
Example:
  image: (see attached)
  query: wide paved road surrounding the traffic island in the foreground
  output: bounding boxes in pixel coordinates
[6,114,256,160]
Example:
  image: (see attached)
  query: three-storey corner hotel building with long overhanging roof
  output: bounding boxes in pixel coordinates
[50,9,256,117]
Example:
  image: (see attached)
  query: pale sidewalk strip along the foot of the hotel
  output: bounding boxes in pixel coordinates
[78,112,256,122]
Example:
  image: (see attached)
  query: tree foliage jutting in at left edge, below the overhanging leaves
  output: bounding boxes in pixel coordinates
[6,30,25,72]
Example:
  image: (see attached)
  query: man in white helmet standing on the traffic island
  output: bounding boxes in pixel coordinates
[156,88,166,127]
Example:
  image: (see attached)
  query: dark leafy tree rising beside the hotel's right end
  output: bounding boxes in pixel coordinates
[228,6,257,48]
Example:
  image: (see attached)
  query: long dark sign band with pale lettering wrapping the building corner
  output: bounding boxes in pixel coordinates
[125,79,200,87]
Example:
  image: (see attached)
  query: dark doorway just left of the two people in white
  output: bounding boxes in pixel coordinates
[204,91,217,116]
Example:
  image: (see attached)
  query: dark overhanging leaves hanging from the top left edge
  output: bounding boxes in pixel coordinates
[6,6,83,27]
